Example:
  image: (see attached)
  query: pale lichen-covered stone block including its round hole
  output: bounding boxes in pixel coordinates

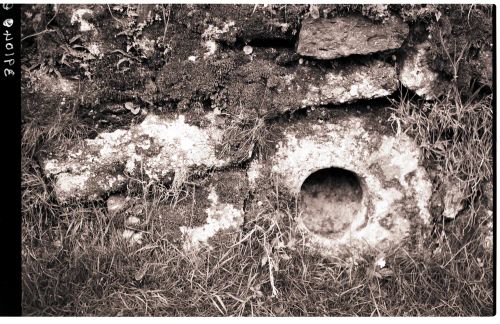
[254,116,432,255]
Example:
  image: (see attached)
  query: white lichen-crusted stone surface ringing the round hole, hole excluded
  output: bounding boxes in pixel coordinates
[270,117,432,255]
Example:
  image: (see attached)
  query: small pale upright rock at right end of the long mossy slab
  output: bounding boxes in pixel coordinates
[399,42,445,100]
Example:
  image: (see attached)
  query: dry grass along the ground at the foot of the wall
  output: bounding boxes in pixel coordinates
[22,114,493,316]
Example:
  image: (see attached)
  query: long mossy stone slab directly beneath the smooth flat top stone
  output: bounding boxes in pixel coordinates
[197,56,398,119]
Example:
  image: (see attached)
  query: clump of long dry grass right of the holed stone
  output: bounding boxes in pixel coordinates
[391,81,493,230]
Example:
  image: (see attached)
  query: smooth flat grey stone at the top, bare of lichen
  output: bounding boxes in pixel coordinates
[297,16,409,60]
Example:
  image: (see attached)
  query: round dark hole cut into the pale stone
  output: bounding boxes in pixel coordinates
[300,168,363,236]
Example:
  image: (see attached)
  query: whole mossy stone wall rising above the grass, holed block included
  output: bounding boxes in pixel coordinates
[23,5,491,256]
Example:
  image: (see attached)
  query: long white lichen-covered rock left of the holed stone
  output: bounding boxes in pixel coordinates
[43,115,242,201]
